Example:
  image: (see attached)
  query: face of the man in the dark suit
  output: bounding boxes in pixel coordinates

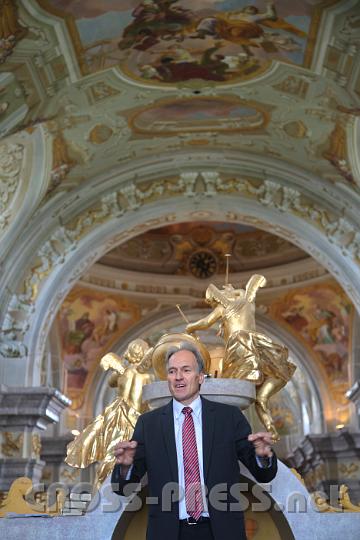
[167,349,204,405]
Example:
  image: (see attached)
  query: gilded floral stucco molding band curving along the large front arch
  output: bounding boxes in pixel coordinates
[1,170,360,356]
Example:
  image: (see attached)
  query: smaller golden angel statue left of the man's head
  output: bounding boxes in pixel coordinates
[65,339,155,488]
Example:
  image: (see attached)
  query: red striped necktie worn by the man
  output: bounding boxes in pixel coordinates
[182,407,204,520]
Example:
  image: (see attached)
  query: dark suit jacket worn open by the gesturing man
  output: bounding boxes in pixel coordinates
[111,398,277,540]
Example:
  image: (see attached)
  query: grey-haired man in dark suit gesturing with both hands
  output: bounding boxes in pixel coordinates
[111,343,277,540]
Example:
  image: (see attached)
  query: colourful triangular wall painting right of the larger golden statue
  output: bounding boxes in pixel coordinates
[269,281,353,405]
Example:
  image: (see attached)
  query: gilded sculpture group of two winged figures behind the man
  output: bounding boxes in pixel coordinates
[66,274,296,487]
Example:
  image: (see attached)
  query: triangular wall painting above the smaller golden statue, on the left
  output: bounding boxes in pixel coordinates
[57,287,141,410]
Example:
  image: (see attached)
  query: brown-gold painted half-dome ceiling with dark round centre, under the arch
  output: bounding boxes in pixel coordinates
[99,222,307,279]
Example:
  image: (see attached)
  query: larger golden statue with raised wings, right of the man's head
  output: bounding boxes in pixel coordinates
[186,274,296,440]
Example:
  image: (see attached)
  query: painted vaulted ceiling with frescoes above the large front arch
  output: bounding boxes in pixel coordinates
[0,0,360,205]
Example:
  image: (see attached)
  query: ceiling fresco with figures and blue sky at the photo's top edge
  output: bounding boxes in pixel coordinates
[38,0,326,83]
